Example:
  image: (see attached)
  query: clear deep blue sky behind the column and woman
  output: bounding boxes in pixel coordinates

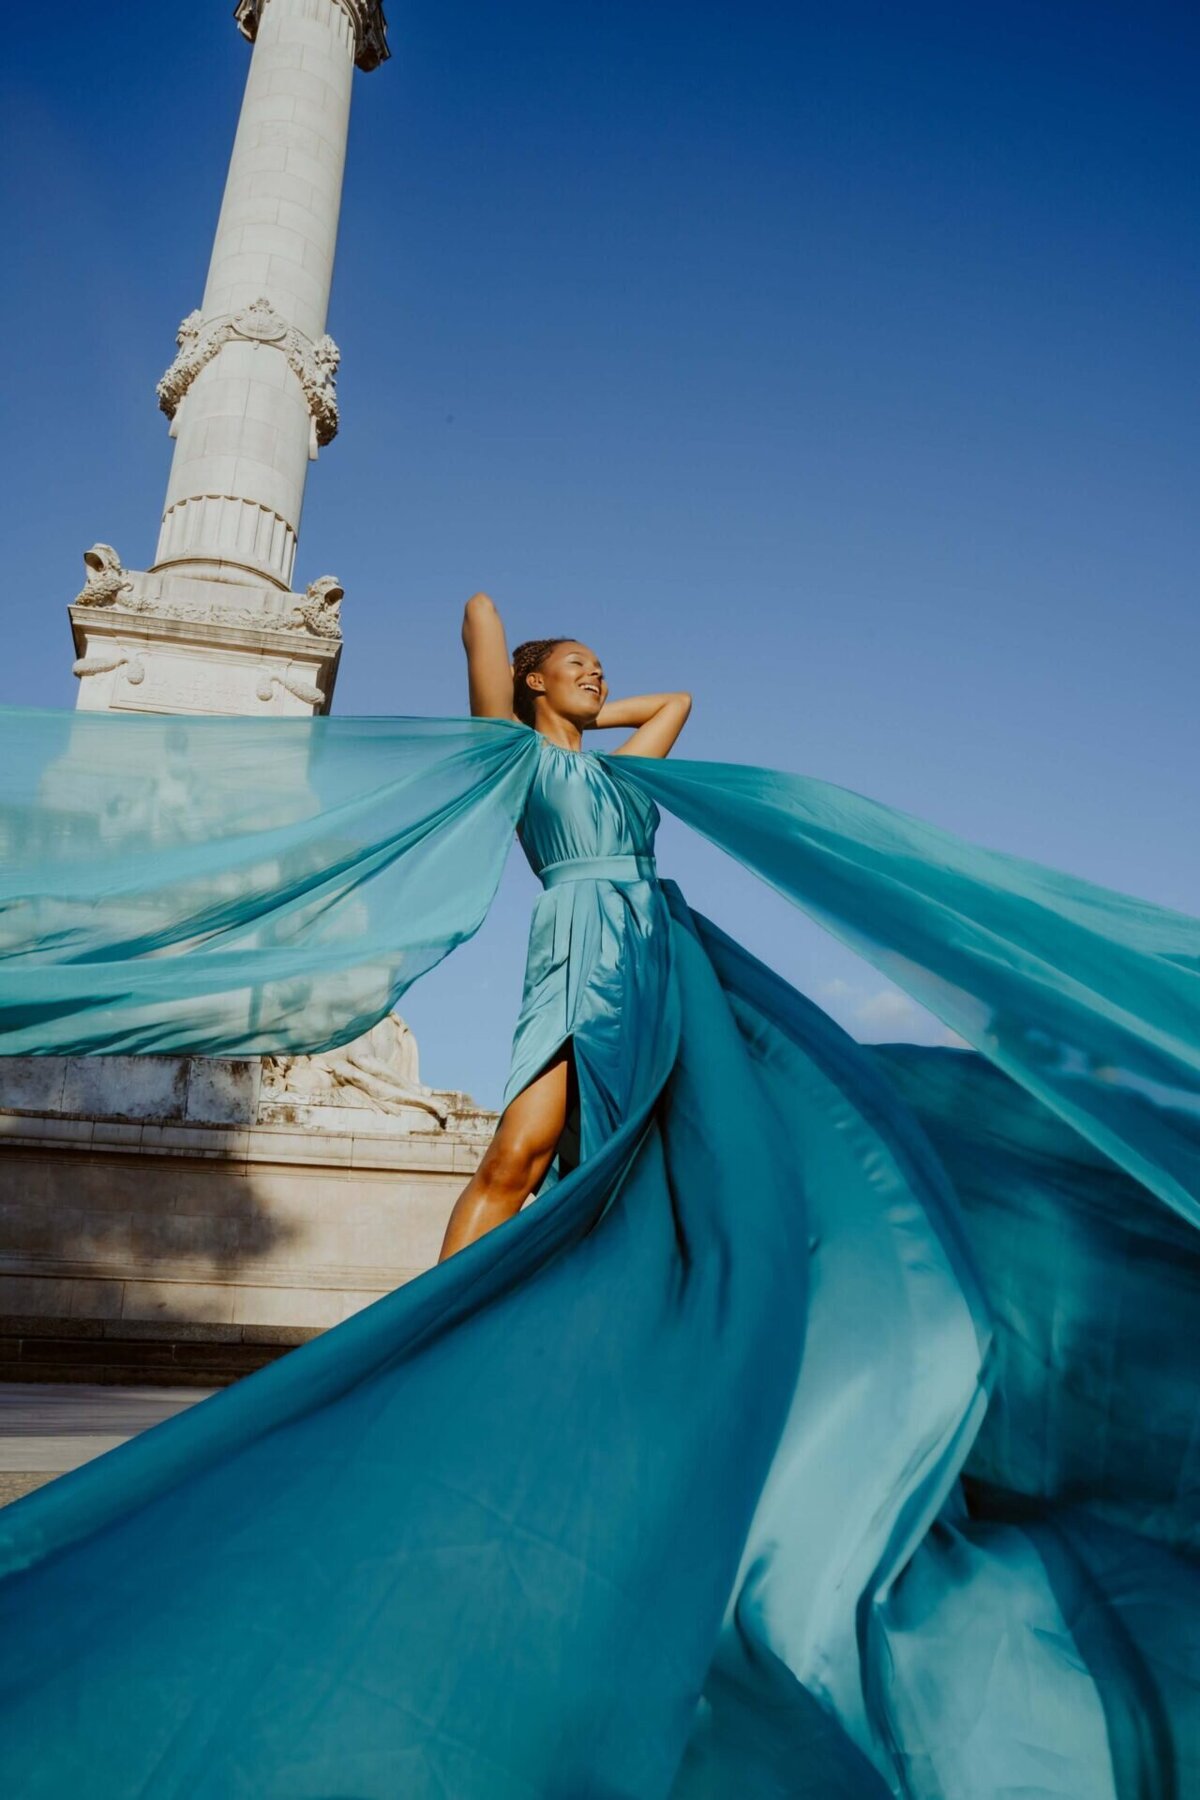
[0,0,1200,1102]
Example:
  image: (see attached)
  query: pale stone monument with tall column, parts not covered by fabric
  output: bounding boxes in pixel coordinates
[0,0,493,1386]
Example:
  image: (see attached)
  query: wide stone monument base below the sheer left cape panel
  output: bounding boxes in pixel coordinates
[0,1017,495,1386]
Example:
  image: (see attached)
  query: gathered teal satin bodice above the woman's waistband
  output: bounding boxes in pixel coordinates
[516,738,658,875]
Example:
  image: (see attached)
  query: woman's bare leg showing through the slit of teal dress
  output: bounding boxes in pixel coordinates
[437,1049,570,1262]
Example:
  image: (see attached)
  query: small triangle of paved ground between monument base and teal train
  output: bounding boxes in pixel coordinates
[0,1381,209,1507]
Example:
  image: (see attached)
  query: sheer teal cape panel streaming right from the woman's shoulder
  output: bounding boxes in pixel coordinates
[637,761,1200,1224]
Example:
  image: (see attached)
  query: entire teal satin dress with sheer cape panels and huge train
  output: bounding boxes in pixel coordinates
[0,713,1200,1800]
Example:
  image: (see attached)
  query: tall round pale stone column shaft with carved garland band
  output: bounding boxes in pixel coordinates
[151,0,387,590]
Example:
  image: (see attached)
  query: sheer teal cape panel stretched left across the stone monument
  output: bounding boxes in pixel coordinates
[0,709,536,1057]
